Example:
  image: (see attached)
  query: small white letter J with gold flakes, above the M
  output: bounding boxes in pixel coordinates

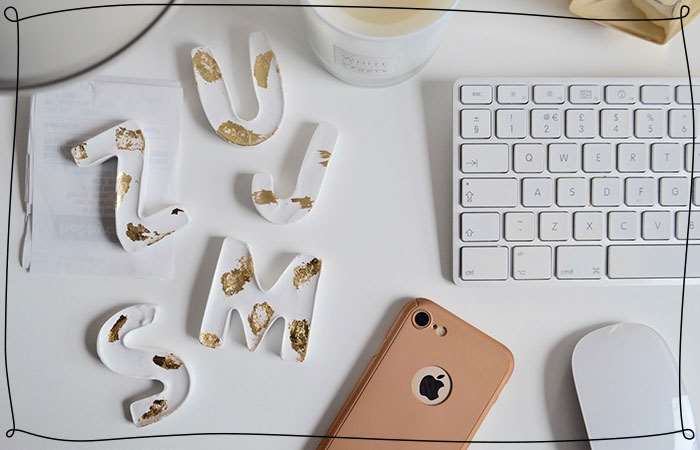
[252,123,338,224]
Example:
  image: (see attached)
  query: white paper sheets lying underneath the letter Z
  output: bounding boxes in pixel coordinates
[22,79,182,278]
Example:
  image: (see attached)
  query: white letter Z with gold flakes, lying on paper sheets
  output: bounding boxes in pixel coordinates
[71,120,189,252]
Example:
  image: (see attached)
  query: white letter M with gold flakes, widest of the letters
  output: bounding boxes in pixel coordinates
[199,238,321,362]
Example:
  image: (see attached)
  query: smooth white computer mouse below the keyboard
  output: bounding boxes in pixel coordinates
[571,323,698,450]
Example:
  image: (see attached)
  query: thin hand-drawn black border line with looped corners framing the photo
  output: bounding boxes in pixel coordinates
[3,0,696,444]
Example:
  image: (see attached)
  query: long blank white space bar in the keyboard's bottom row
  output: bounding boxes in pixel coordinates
[608,245,700,278]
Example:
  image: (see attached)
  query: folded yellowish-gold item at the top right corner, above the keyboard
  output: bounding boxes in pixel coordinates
[569,0,700,44]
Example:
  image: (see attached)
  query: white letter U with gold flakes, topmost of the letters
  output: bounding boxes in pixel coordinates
[192,31,284,147]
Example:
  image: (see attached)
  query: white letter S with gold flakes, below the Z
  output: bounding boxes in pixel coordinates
[97,304,190,427]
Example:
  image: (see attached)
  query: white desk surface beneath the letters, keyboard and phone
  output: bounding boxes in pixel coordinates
[0,0,700,450]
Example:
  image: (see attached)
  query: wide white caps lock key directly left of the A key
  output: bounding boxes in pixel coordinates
[462,178,518,208]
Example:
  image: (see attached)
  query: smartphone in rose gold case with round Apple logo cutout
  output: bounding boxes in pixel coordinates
[318,299,513,450]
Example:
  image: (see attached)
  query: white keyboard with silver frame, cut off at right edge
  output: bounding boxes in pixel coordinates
[453,78,700,284]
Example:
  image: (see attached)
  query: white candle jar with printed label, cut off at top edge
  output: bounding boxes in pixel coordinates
[304,0,458,87]
